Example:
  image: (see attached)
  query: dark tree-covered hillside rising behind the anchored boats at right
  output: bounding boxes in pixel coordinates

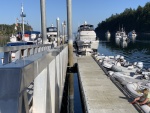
[95,2,150,35]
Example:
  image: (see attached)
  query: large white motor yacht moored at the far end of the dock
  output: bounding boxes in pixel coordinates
[75,22,99,55]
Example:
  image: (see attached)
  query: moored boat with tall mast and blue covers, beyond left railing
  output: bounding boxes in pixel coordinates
[6,5,42,61]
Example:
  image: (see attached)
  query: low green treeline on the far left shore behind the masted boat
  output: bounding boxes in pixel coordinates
[0,23,32,36]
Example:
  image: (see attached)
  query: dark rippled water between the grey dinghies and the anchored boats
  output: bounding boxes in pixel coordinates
[98,35,150,68]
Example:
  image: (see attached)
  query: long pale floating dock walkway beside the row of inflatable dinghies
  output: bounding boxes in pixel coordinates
[77,56,141,113]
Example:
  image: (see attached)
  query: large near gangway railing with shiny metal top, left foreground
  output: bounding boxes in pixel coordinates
[0,45,68,113]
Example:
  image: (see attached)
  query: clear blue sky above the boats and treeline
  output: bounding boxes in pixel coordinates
[0,0,149,32]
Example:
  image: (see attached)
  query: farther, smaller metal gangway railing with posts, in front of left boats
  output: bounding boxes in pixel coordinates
[0,44,52,64]
